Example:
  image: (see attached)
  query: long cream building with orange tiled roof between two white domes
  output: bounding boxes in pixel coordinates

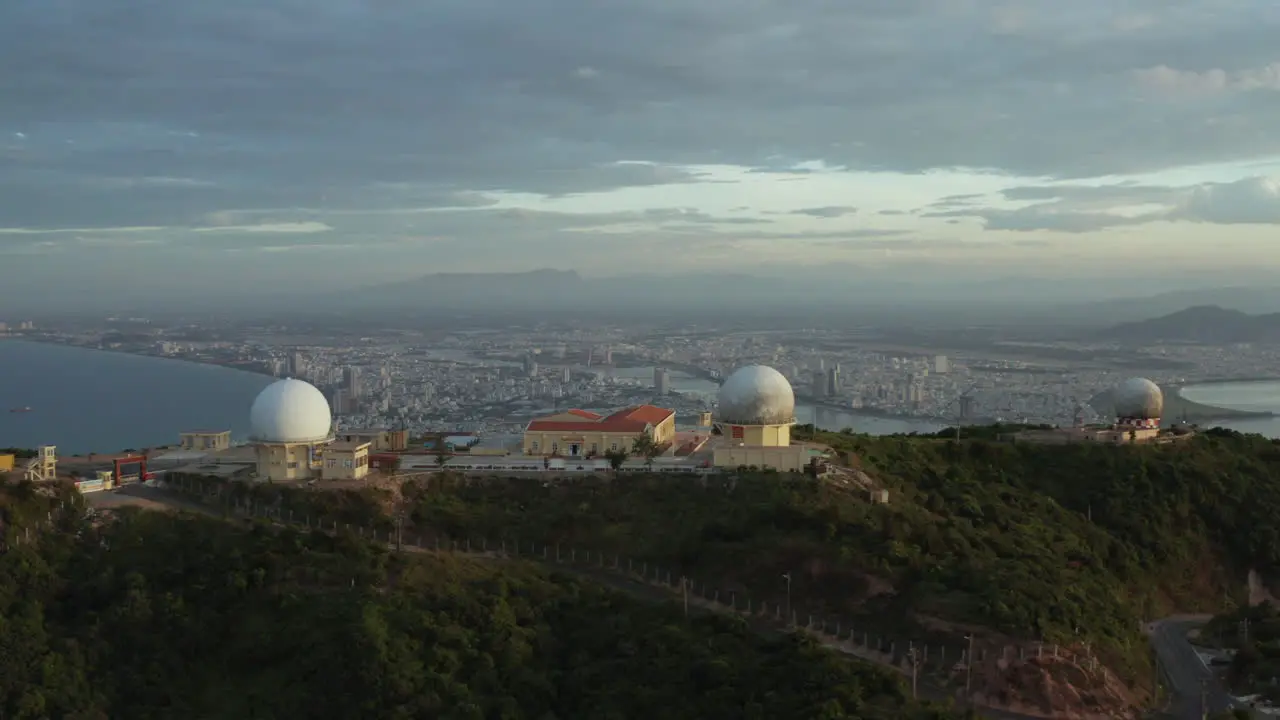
[524,405,676,457]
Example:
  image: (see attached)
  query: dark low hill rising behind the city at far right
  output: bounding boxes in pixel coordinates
[1098,305,1280,345]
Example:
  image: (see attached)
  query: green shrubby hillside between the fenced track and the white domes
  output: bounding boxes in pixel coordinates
[186,428,1280,671]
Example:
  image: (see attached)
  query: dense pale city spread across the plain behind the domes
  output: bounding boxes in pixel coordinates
[0,319,1280,443]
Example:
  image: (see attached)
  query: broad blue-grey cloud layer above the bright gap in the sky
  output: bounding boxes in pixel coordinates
[0,0,1280,240]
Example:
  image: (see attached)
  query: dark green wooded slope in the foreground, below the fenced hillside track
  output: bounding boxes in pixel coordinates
[0,484,952,720]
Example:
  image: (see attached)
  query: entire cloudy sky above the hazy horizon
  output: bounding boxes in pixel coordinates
[0,0,1280,297]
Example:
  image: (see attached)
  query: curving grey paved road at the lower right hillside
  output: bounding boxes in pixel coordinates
[1148,618,1235,720]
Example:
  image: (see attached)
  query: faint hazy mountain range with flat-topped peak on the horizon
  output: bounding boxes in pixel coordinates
[329,266,1280,328]
